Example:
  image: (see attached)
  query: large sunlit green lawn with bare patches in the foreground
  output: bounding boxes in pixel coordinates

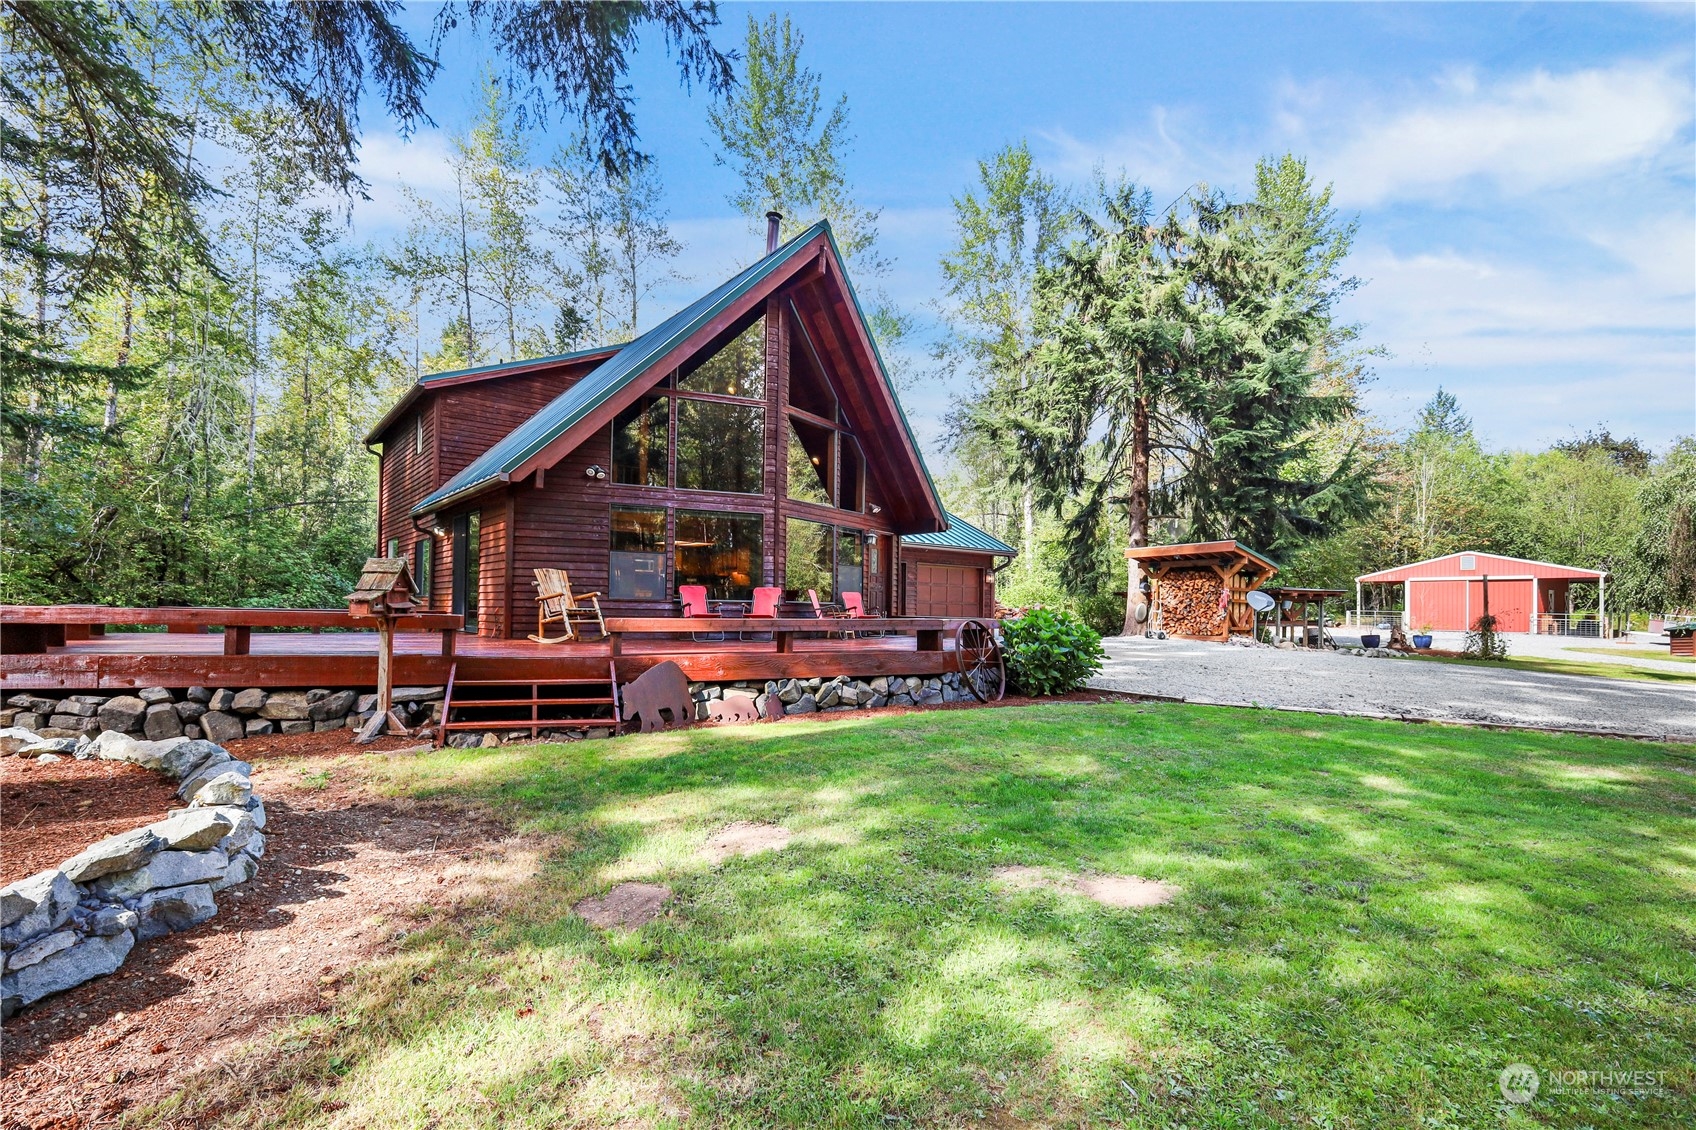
[159,704,1696,1128]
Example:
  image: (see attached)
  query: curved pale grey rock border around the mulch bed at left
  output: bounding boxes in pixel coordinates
[0,726,265,1016]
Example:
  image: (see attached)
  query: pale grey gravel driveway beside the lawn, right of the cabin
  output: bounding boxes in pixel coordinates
[1089,636,1696,740]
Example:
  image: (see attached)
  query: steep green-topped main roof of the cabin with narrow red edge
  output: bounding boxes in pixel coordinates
[412,221,943,526]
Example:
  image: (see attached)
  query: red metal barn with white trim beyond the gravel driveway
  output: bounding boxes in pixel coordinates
[1355,551,1608,635]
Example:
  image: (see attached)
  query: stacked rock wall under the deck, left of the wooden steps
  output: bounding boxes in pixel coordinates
[0,687,443,741]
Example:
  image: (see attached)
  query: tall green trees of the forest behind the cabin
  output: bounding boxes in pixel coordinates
[0,3,1696,628]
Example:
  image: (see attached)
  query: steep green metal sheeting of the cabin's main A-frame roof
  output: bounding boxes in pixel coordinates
[412,221,942,536]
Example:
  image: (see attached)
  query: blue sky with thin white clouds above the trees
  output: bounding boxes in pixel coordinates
[354,3,1696,450]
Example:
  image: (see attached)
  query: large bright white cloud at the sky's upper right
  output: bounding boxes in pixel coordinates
[1316,63,1693,205]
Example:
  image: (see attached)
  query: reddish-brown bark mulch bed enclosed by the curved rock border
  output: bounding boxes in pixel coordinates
[0,757,183,886]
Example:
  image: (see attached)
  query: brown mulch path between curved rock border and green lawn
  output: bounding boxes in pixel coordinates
[0,733,539,1130]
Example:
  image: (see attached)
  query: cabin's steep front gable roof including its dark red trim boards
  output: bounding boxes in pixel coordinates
[412,221,946,533]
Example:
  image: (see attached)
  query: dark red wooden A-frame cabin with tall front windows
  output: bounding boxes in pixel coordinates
[366,222,1014,638]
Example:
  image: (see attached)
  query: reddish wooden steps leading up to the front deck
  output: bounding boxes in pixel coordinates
[436,662,619,747]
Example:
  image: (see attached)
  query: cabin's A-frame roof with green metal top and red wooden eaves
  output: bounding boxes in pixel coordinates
[412,221,946,533]
